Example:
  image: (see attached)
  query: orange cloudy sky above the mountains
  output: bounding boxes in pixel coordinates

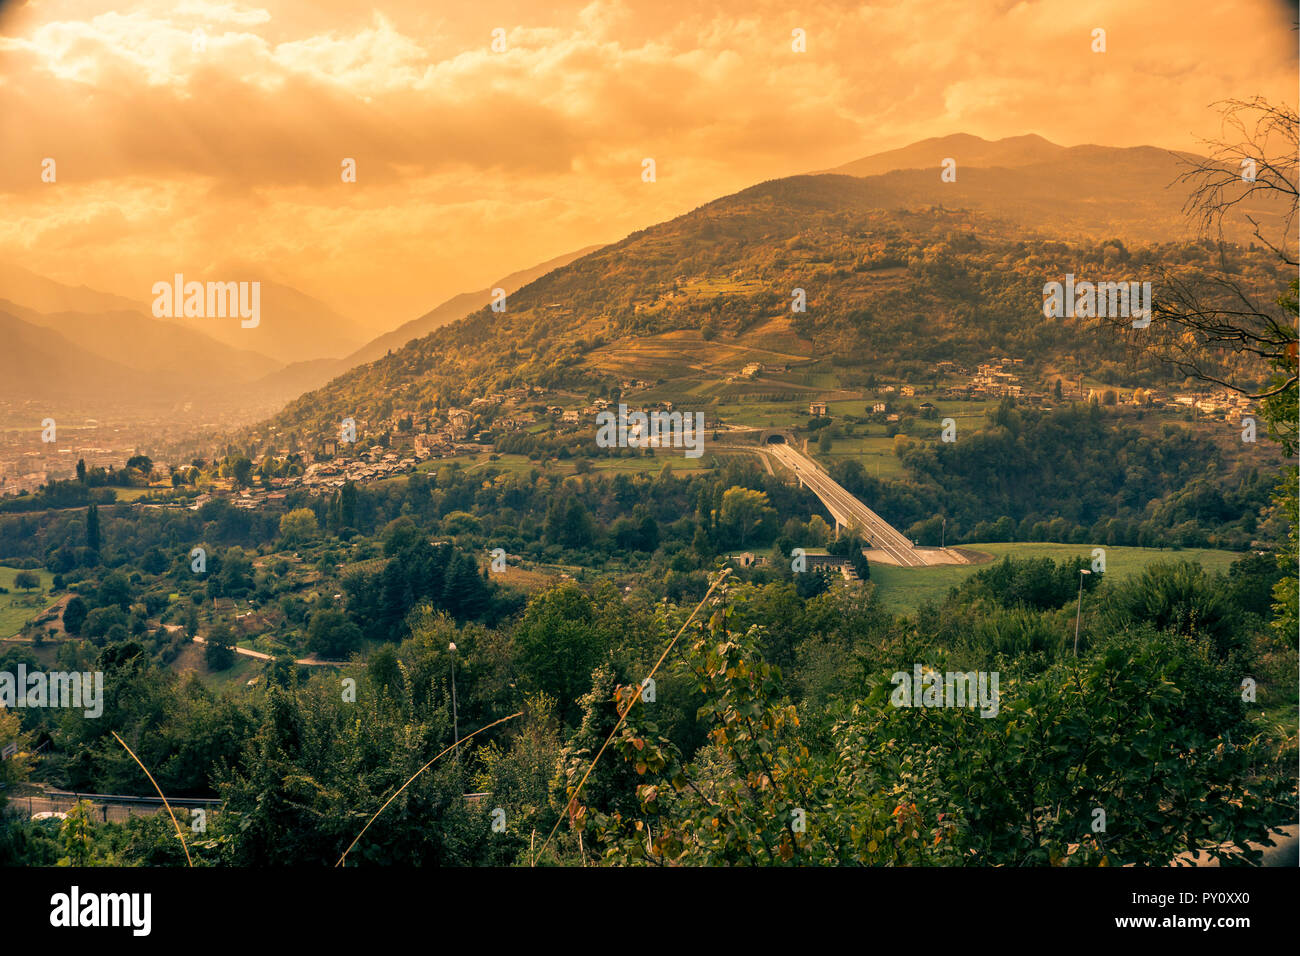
[0,0,1297,333]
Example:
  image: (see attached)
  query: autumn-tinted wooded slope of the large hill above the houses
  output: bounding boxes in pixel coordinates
[256,170,1282,444]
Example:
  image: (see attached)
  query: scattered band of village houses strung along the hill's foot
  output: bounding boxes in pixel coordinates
[0,356,1251,509]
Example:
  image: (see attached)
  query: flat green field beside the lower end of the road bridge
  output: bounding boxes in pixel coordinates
[867,541,1244,614]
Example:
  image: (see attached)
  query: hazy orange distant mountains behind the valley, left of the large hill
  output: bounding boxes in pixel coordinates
[0,246,598,421]
